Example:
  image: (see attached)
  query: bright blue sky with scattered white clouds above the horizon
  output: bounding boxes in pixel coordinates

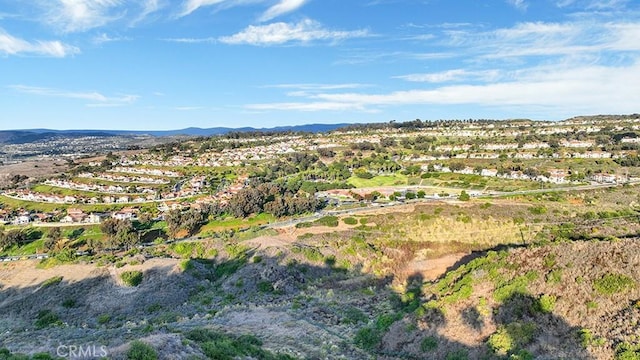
[0,0,640,130]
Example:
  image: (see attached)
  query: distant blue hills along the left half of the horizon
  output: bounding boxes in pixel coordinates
[0,124,351,144]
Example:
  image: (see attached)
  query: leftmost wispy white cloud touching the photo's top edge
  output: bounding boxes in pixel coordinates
[42,0,124,32]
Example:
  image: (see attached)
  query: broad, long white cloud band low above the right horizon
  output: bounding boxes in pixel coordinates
[246,61,640,114]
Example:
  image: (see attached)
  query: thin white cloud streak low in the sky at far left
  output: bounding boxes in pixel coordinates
[9,85,139,107]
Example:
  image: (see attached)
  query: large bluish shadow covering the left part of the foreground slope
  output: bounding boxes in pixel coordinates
[0,249,376,358]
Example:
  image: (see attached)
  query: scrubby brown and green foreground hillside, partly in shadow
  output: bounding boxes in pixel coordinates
[0,195,640,359]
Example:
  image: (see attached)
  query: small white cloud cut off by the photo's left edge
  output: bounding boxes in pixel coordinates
[0,29,80,57]
